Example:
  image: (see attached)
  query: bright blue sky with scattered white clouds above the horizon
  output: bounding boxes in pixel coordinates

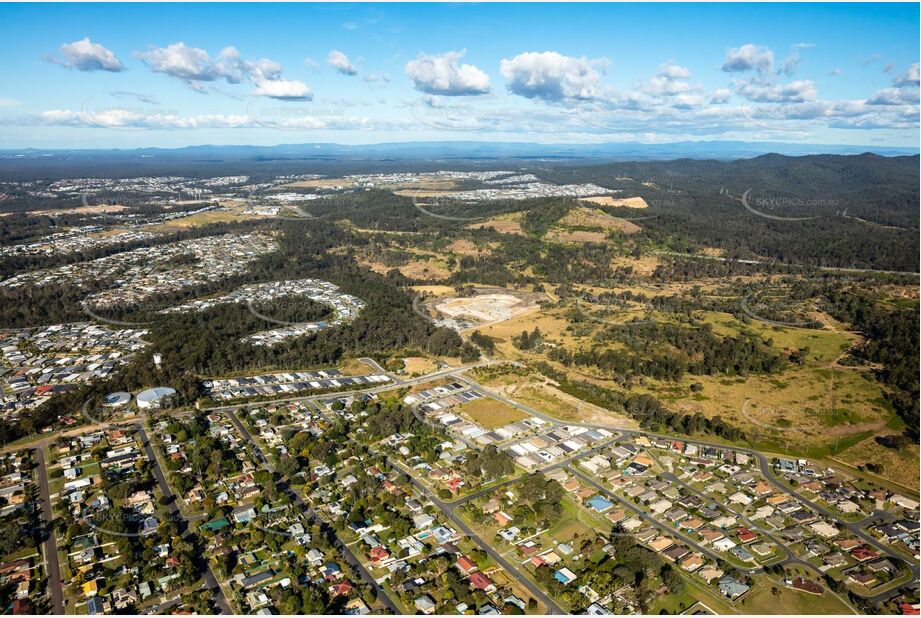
[0,3,921,149]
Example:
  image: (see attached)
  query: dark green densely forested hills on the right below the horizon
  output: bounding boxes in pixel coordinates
[541,154,919,272]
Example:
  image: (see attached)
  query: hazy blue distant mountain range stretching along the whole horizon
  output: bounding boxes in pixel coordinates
[0,141,919,180]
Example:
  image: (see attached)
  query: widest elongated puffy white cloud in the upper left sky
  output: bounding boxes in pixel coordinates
[136,41,282,91]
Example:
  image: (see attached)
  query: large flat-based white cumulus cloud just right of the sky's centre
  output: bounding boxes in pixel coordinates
[499,51,607,101]
